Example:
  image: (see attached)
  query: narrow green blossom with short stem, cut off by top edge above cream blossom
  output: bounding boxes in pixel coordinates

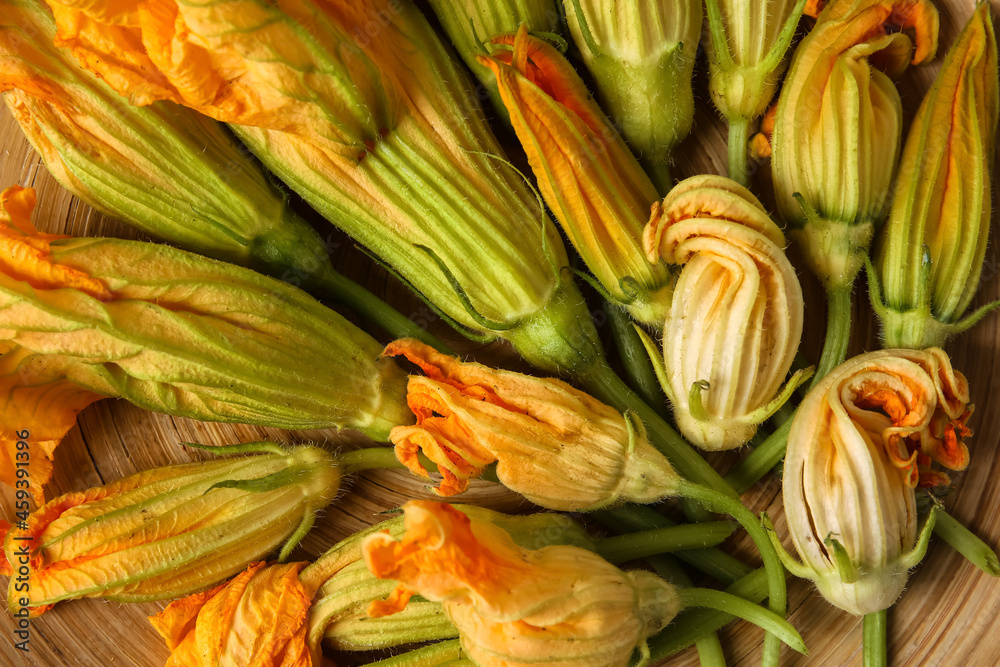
[705,0,806,185]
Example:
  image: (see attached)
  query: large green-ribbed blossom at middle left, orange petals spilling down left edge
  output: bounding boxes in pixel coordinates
[0,186,413,501]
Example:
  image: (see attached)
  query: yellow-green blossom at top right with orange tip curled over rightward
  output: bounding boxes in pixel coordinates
[771,0,938,291]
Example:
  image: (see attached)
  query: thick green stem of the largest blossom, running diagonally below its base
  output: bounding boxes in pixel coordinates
[581,363,736,499]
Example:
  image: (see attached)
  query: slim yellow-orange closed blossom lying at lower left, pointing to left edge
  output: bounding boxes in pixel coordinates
[2,443,340,616]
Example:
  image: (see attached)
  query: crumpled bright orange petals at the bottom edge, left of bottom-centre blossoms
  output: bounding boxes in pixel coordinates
[149,562,312,667]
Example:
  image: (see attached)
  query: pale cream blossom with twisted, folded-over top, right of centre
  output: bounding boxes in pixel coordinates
[644,176,811,450]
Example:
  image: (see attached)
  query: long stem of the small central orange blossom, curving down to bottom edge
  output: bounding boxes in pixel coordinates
[677,481,787,667]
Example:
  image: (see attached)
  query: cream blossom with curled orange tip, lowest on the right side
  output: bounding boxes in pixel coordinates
[775,348,972,615]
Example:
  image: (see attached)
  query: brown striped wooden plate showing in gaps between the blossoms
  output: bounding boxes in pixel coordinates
[0,0,1000,667]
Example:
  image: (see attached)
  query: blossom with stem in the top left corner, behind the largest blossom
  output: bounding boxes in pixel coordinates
[0,0,442,352]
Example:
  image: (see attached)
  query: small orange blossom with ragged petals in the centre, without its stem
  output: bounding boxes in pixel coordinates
[386,339,679,511]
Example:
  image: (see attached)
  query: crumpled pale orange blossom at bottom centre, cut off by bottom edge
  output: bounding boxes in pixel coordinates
[362,500,680,667]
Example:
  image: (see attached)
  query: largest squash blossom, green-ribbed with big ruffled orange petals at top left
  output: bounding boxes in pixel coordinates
[50,0,602,373]
